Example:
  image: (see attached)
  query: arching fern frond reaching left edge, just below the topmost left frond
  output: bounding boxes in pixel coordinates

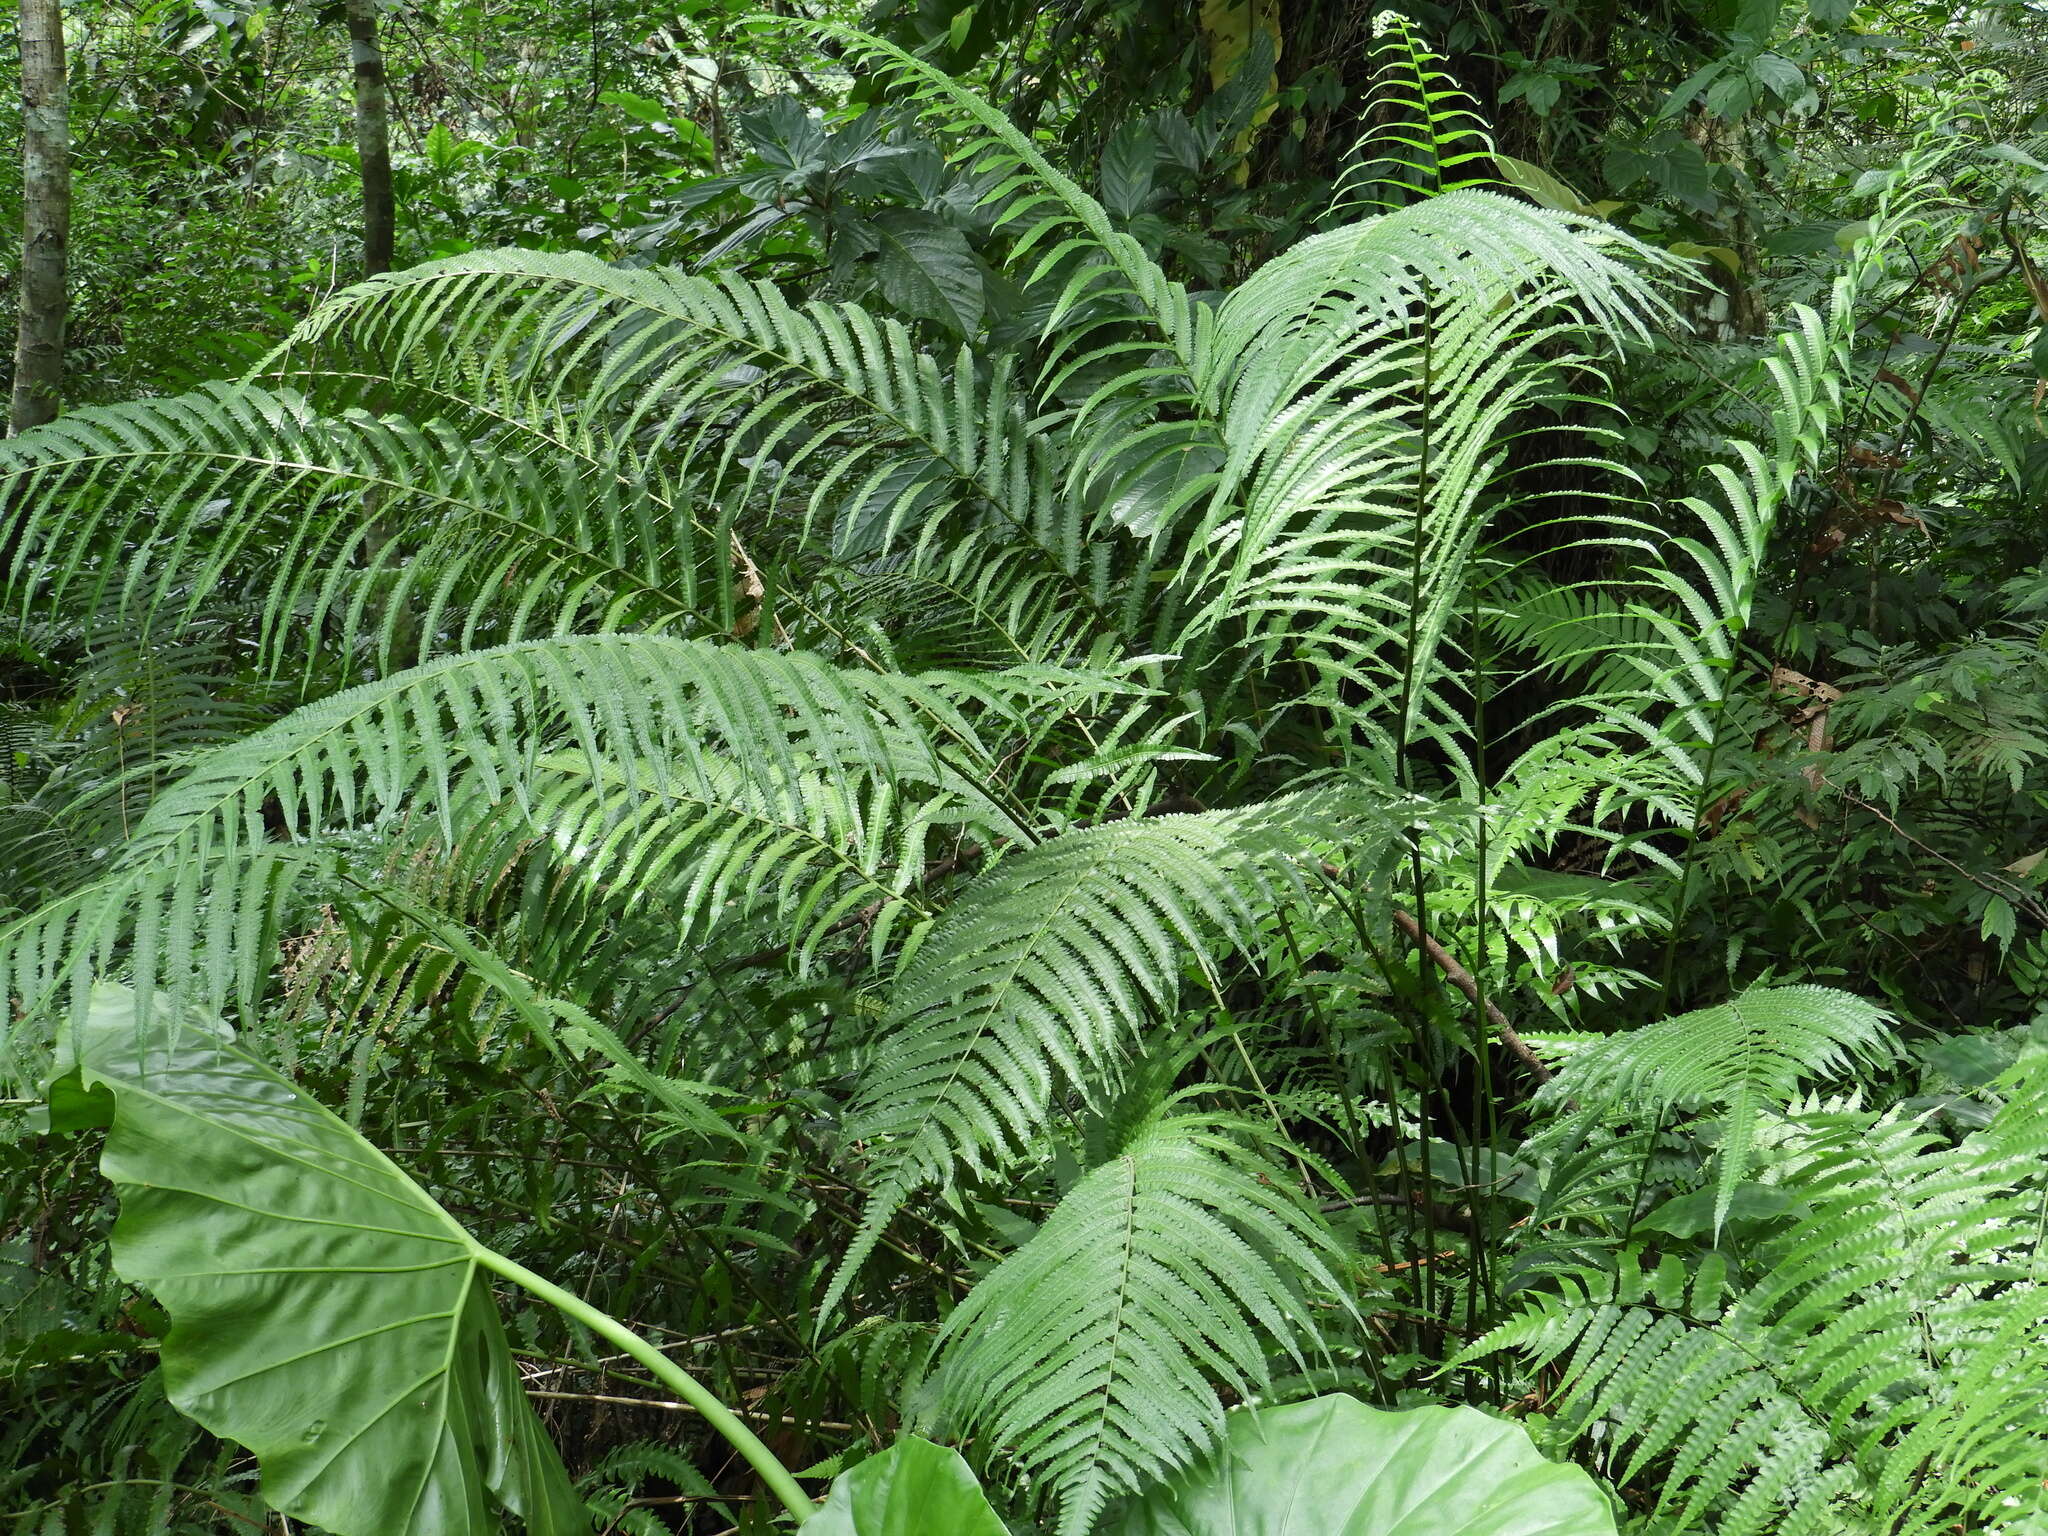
[0,385,725,666]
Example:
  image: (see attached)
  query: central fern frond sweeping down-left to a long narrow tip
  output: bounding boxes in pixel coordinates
[821,797,1359,1311]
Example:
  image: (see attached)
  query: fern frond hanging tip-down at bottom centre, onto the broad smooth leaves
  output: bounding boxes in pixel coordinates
[922,1116,1350,1536]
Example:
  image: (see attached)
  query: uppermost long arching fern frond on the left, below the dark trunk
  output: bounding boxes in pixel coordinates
[266,250,1077,569]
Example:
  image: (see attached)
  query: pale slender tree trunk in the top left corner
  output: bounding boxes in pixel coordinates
[8,0,72,432]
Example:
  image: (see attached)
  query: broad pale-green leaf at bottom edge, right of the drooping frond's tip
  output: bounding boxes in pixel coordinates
[1102,1397,1614,1536]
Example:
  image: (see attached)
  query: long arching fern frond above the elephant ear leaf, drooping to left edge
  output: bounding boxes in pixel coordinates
[0,635,1030,1056]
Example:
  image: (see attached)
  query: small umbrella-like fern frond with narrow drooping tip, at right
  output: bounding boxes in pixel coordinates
[1542,987,1894,1231]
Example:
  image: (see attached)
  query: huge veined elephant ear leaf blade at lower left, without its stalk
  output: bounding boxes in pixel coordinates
[53,987,590,1536]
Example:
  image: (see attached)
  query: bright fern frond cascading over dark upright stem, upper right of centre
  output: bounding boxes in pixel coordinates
[1155,190,1665,758]
